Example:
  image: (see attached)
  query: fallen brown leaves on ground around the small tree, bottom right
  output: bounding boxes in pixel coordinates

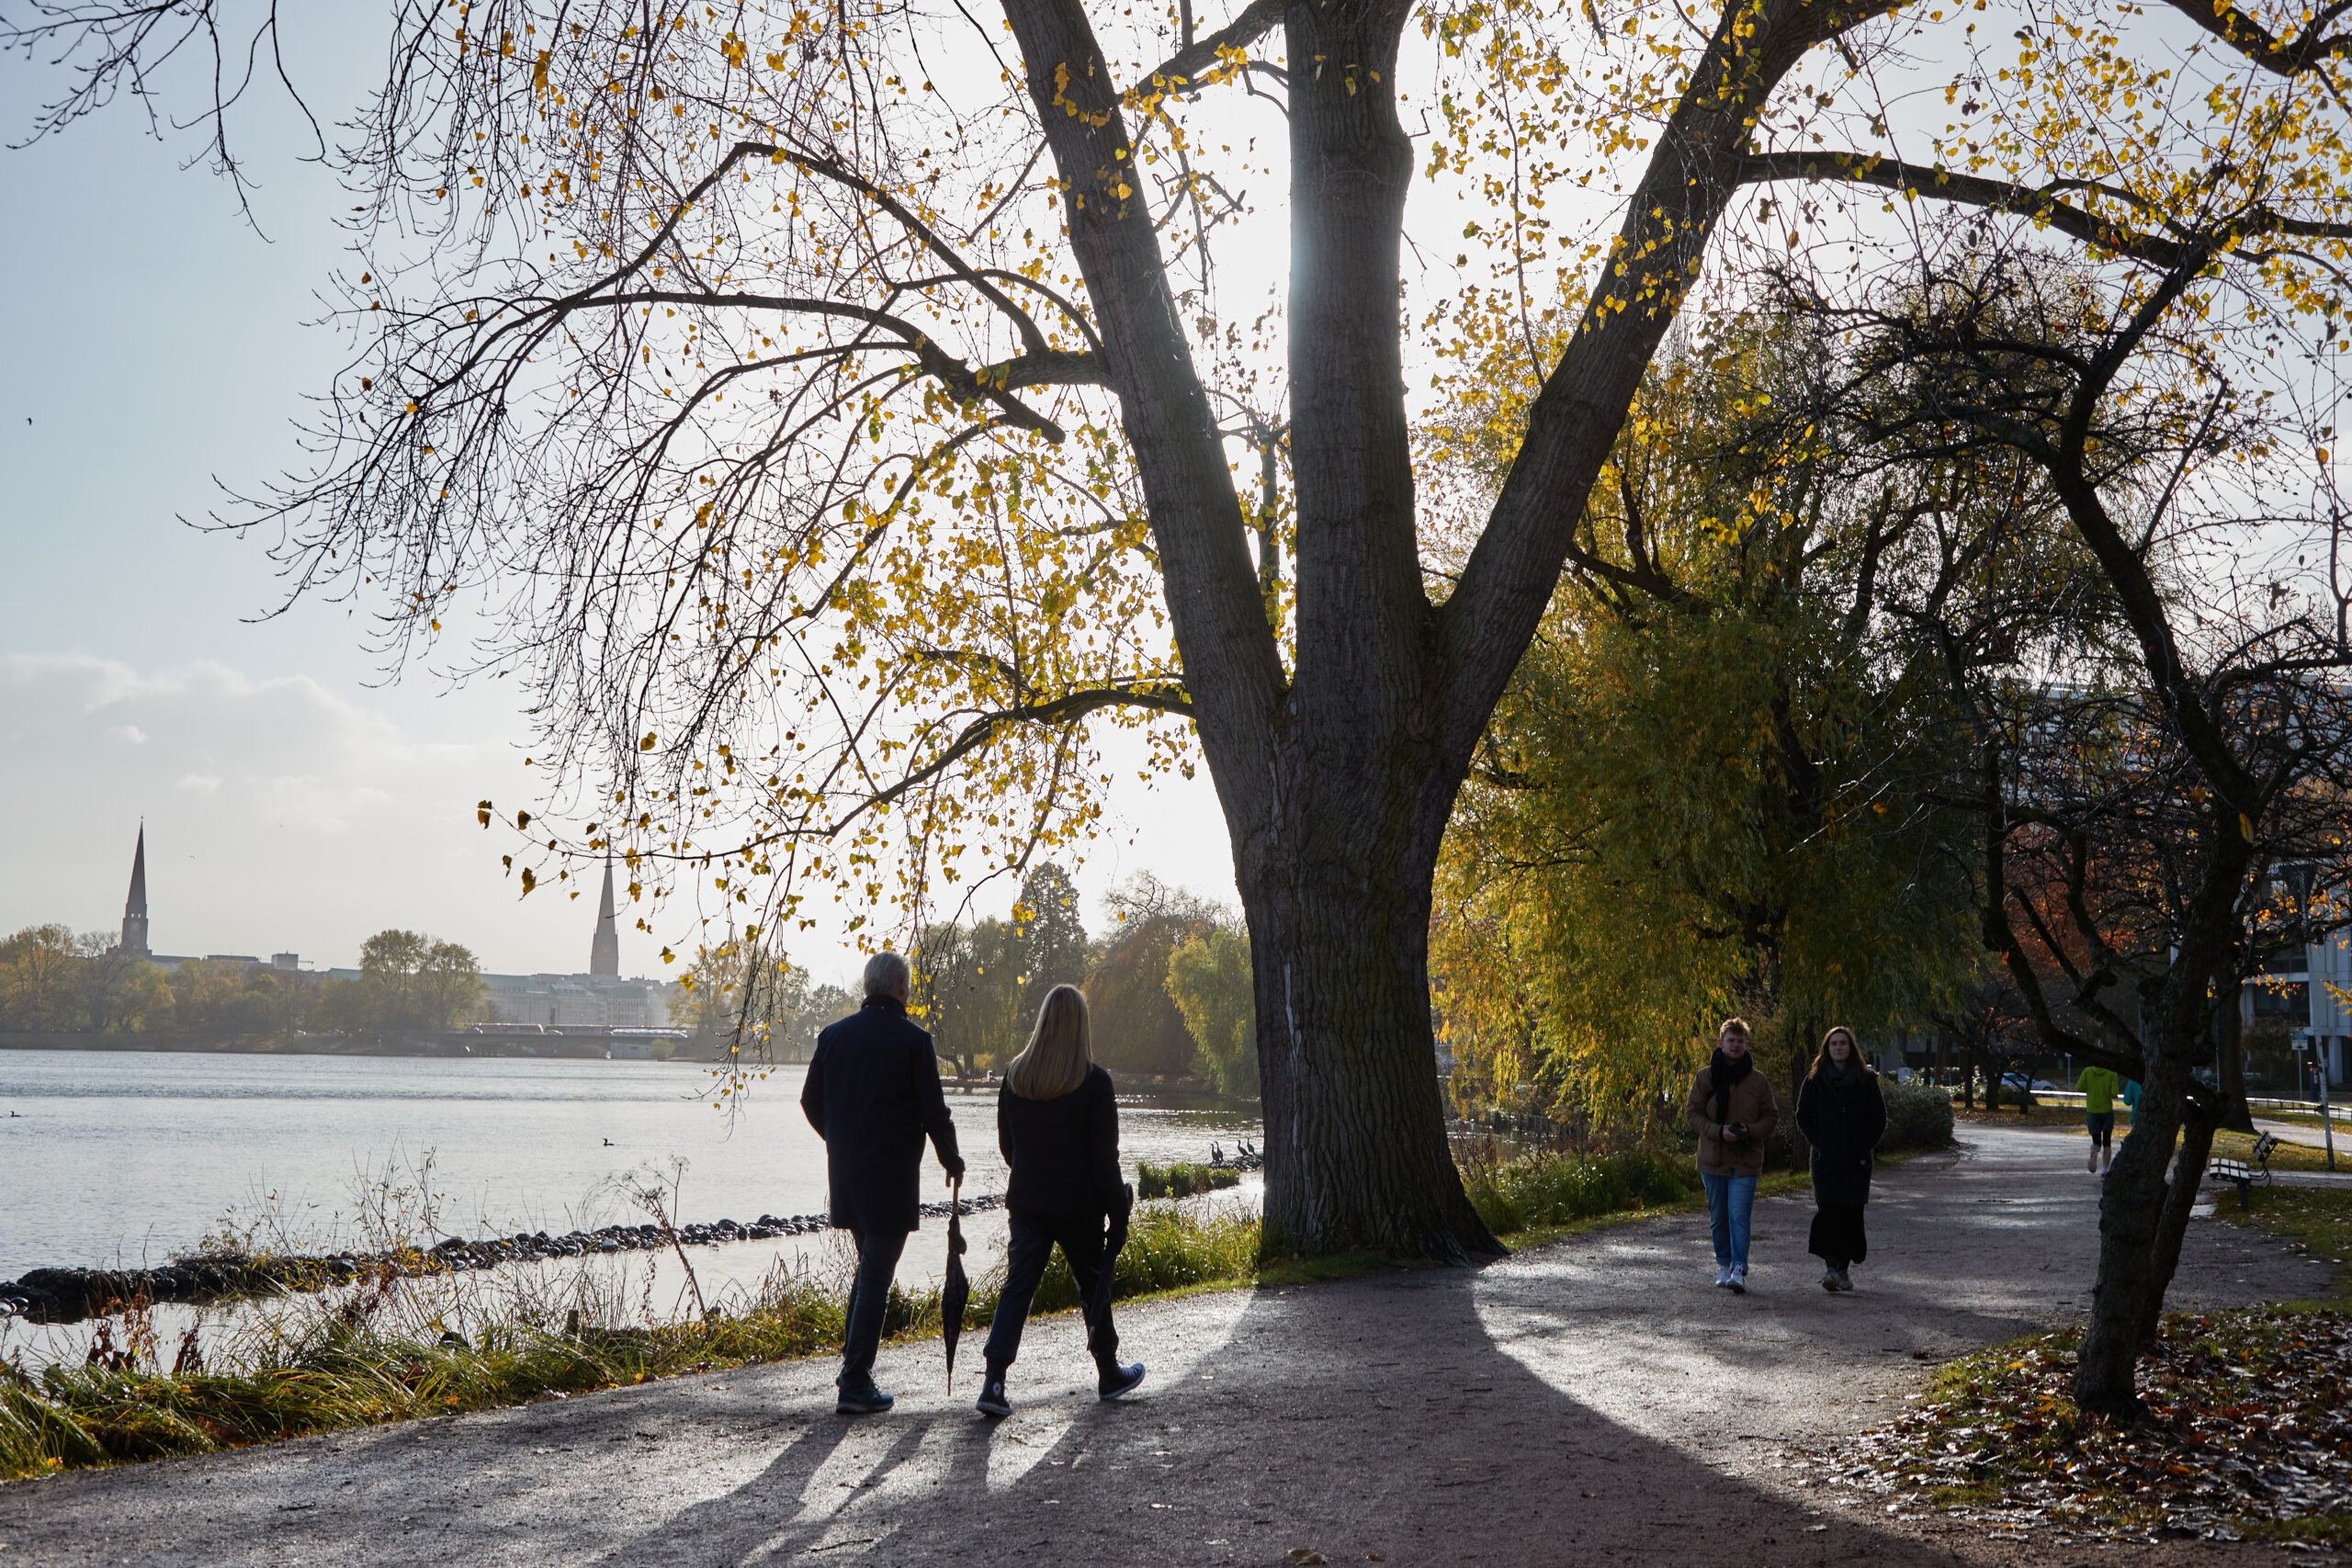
[1839,1309,2352,1542]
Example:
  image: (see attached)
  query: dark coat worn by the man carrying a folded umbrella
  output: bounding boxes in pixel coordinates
[799,997,962,1232]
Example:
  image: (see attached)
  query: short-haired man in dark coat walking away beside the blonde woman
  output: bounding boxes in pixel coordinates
[799,952,965,1416]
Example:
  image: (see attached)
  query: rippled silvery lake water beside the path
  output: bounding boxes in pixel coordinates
[0,1051,1259,1279]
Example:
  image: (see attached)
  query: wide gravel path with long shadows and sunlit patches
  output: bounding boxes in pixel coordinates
[0,1128,2328,1568]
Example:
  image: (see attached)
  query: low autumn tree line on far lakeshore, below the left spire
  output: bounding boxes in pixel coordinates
[0,924,487,1043]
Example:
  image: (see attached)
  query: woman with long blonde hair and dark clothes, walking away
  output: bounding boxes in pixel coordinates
[981,985,1143,1416]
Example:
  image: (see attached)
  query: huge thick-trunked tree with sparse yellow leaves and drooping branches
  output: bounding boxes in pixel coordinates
[18,0,2340,1258]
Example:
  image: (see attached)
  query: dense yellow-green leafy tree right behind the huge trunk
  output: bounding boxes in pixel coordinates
[1432,312,2031,1122]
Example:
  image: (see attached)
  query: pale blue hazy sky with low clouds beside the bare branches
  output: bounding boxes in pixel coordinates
[0,15,1235,978]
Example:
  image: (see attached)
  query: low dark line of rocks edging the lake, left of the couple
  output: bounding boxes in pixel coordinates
[0,1192,1004,1324]
